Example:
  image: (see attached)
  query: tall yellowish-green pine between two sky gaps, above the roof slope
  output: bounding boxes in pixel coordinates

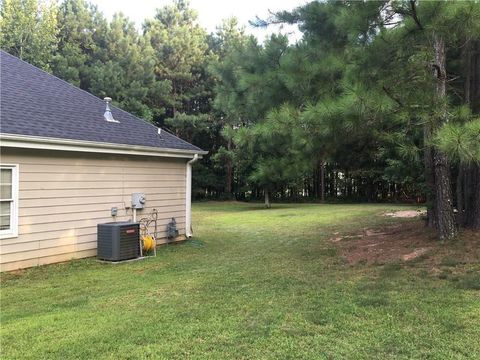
[144,1,209,131]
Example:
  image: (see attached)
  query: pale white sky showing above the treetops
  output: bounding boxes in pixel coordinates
[90,0,308,42]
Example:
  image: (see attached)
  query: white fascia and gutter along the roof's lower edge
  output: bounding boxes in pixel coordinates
[0,134,208,159]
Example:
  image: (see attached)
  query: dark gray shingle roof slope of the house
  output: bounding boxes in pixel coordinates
[0,51,201,151]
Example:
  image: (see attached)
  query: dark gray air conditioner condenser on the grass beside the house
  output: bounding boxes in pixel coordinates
[97,221,140,261]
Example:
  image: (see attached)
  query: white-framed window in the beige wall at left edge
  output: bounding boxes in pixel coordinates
[0,164,18,239]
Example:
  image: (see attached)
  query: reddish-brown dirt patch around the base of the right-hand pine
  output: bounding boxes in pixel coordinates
[331,220,480,267]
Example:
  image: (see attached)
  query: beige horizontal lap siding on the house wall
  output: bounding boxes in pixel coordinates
[0,148,186,271]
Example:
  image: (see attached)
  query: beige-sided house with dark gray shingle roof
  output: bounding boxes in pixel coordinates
[0,51,206,271]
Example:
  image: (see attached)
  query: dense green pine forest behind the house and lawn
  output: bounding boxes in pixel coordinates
[0,0,480,239]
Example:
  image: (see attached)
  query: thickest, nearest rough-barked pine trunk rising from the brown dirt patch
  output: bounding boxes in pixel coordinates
[433,35,457,240]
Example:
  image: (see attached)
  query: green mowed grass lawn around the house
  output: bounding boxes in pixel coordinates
[1,203,480,359]
